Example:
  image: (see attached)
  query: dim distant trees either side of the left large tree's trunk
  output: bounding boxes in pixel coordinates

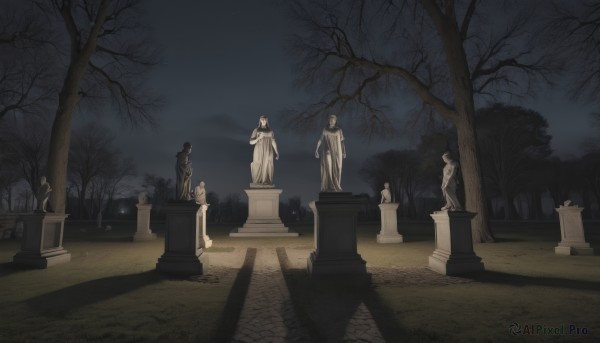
[0,117,136,219]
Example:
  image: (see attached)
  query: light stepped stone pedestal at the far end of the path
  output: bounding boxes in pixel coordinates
[229,187,298,237]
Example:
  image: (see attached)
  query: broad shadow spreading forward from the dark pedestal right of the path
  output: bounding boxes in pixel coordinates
[277,248,407,342]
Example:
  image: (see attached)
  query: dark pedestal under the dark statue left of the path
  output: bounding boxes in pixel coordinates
[156,202,208,276]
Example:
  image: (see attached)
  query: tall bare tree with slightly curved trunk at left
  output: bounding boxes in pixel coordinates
[27,0,158,212]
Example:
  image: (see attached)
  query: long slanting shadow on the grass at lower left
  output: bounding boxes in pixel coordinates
[25,270,165,317]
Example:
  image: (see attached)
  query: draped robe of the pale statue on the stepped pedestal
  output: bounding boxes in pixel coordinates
[250,128,275,185]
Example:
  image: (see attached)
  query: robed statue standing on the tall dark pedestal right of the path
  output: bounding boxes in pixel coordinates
[315,114,346,192]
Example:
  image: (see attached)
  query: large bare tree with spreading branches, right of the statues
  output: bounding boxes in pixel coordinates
[293,0,554,242]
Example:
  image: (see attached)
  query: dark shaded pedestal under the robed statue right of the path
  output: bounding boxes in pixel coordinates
[307,192,367,276]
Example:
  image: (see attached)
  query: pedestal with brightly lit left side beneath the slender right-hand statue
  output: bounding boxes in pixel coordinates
[429,211,484,275]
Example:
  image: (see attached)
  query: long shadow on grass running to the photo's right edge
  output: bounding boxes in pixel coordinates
[469,270,600,291]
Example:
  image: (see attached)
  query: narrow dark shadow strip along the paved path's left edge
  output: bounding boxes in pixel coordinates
[214,248,256,342]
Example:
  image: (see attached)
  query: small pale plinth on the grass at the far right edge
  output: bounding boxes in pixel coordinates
[554,205,594,255]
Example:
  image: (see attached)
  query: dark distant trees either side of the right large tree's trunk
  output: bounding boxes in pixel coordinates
[361,103,600,220]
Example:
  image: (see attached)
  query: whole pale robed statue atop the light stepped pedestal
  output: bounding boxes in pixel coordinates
[250,116,279,186]
